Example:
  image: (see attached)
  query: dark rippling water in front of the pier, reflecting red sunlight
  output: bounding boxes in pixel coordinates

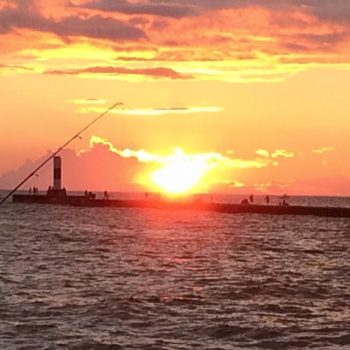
[0,200,350,350]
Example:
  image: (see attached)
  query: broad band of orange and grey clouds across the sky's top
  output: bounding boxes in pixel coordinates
[0,0,350,82]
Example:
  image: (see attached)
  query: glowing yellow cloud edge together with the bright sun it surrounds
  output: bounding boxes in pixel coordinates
[87,136,270,193]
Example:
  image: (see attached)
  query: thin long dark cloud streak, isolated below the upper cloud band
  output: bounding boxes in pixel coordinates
[46,66,192,79]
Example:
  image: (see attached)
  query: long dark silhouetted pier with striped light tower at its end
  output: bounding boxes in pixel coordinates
[12,156,350,218]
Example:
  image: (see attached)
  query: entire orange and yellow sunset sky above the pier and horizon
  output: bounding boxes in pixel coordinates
[0,0,350,195]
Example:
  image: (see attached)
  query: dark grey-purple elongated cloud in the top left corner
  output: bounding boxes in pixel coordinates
[0,1,146,40]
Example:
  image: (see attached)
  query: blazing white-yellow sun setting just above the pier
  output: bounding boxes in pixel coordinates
[151,148,209,195]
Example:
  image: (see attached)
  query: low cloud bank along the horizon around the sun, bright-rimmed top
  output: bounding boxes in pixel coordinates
[0,136,350,195]
